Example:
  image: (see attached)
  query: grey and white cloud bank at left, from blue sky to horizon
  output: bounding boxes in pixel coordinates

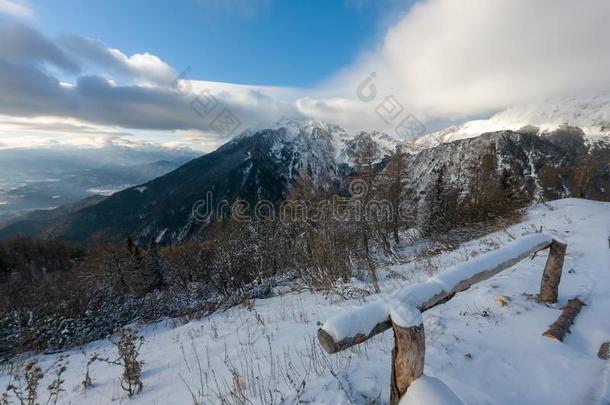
[0,22,296,150]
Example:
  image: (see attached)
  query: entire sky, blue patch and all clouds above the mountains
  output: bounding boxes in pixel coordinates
[0,0,610,151]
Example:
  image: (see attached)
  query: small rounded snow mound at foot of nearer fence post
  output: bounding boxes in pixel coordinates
[400,375,464,405]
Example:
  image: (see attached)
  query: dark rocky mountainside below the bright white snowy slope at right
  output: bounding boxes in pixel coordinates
[409,127,610,202]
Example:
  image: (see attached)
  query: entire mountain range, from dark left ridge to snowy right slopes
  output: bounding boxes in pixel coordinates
[2,107,610,244]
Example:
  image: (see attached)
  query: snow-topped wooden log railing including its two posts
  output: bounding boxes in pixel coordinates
[318,233,567,404]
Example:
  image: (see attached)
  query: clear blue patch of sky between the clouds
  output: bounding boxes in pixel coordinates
[30,0,411,87]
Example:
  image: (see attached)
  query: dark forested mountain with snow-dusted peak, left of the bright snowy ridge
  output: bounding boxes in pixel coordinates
[39,121,381,244]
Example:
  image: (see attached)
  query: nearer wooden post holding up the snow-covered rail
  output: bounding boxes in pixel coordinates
[390,322,426,405]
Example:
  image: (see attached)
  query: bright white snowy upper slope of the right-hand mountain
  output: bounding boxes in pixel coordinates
[409,96,610,151]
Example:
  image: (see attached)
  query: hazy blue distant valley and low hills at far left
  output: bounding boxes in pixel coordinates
[0,143,201,223]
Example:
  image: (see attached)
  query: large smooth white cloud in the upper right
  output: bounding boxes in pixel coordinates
[327,0,610,120]
